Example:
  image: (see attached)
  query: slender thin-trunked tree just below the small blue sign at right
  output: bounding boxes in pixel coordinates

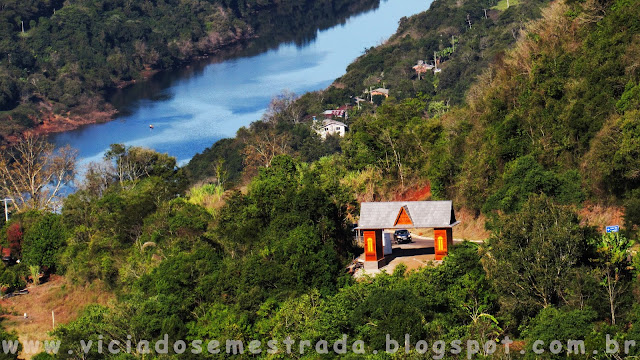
[593,233,634,325]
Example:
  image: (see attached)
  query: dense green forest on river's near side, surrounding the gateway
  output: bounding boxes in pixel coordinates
[0,0,640,359]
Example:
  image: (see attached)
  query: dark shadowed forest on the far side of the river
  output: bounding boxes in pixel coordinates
[0,0,379,143]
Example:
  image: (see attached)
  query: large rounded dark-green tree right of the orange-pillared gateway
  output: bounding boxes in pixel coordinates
[483,195,586,320]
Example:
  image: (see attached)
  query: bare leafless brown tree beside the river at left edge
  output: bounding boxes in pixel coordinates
[0,135,77,212]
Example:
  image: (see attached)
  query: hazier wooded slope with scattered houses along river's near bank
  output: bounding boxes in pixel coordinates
[187,0,546,181]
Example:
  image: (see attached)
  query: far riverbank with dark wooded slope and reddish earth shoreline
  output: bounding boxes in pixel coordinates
[0,0,379,146]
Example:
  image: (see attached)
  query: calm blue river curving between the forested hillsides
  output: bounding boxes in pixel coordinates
[52,0,431,165]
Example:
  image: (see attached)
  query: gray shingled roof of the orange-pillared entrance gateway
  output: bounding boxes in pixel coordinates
[358,200,459,229]
